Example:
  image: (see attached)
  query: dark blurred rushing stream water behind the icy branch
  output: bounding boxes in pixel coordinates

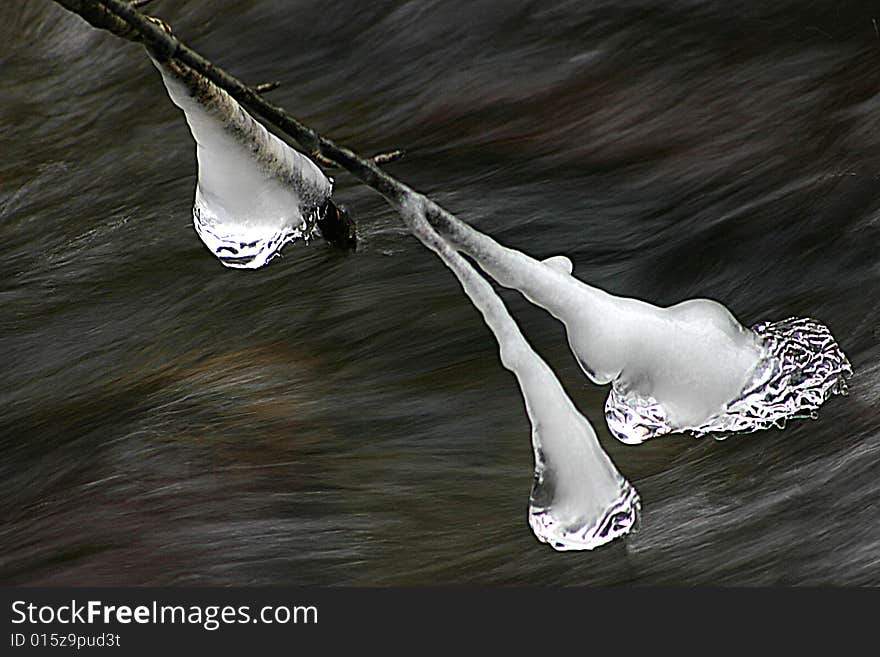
[0,0,880,585]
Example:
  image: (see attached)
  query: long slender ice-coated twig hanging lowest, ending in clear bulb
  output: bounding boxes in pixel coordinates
[400,195,640,550]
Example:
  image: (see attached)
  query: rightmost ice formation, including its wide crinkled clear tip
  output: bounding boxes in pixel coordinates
[422,206,852,444]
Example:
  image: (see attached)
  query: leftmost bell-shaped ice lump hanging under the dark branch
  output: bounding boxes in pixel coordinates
[153,60,333,269]
